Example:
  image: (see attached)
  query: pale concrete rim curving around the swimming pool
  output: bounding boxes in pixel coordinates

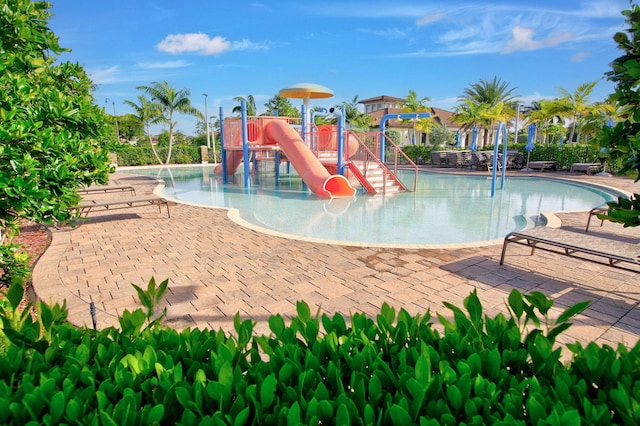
[116,163,632,250]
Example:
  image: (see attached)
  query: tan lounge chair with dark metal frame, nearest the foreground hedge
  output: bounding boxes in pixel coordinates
[500,227,640,273]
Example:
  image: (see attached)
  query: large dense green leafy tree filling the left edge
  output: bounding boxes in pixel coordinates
[0,0,111,235]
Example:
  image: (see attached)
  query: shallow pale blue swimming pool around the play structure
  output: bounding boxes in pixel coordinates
[119,166,619,248]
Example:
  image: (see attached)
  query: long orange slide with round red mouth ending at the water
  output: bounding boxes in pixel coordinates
[264,120,356,198]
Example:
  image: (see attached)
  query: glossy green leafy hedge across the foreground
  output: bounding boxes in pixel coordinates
[0,280,640,426]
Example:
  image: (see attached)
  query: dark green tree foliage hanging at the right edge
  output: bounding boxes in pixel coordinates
[598,5,640,226]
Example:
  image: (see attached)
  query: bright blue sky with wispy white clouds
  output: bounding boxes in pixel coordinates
[49,0,629,134]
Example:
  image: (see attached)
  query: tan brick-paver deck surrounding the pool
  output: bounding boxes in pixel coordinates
[33,169,640,346]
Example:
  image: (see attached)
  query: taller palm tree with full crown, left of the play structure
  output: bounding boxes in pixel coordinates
[137,81,205,164]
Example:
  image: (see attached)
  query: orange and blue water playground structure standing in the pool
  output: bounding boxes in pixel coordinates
[216,102,418,198]
